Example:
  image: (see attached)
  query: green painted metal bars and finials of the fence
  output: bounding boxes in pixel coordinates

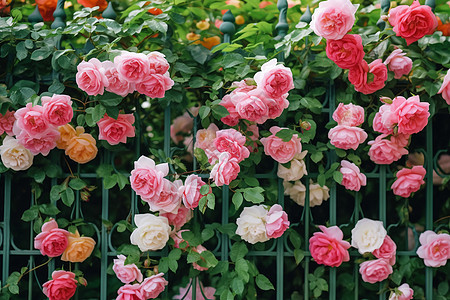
[0,0,444,300]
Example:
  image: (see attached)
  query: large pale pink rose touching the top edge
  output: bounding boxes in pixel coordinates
[310,0,357,40]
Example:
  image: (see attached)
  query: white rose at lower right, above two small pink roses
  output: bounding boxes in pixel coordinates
[352,218,387,254]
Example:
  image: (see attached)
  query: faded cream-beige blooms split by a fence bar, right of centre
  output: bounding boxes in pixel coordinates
[283,179,330,207]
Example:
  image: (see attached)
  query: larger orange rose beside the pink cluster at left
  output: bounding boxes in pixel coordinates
[66,126,98,164]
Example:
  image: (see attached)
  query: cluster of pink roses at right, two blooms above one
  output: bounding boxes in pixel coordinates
[368,96,430,164]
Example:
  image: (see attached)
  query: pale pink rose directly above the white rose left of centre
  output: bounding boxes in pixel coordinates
[147,178,183,213]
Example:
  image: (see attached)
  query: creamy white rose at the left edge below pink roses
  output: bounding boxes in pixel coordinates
[0,136,34,171]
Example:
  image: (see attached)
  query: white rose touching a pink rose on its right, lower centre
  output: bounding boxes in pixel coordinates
[236,205,269,244]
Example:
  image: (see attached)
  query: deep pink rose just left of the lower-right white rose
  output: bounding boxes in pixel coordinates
[309,225,350,267]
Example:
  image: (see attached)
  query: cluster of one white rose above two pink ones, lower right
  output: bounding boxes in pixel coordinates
[351,218,397,283]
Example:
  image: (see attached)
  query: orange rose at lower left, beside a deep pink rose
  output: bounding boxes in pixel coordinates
[61,230,95,262]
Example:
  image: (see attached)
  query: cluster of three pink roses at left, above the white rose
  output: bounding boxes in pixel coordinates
[0,94,73,163]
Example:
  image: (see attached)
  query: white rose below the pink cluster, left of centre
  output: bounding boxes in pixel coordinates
[130,214,171,252]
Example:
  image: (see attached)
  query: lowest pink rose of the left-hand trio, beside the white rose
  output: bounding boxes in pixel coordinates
[13,127,60,156]
